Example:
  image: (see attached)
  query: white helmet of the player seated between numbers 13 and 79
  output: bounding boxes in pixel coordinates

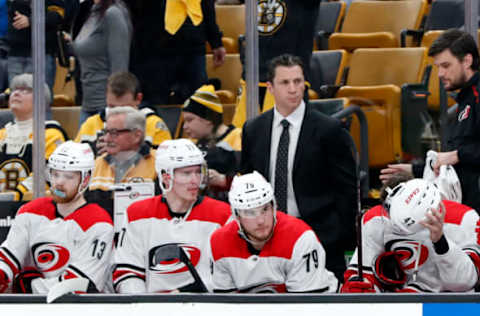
[155,138,207,193]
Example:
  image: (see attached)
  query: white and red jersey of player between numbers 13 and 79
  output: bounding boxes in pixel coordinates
[113,195,231,293]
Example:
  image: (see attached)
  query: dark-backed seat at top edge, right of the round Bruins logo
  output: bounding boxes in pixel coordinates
[314,1,347,50]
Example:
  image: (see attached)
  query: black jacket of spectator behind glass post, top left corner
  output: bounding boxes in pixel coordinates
[7,0,65,57]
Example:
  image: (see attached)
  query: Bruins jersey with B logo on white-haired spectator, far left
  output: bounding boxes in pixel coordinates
[0,121,68,200]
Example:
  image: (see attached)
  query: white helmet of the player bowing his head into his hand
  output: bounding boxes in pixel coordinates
[385,179,442,235]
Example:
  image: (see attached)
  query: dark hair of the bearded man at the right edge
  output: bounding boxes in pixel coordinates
[428,29,479,71]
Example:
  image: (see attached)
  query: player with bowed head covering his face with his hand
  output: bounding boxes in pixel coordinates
[341,174,480,293]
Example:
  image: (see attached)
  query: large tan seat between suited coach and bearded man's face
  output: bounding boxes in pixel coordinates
[337,47,426,168]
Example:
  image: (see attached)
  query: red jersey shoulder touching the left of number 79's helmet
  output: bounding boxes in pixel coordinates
[188,196,232,226]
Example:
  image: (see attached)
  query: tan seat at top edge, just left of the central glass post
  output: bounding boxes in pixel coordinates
[207,4,245,53]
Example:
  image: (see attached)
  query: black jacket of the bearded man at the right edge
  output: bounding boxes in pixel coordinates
[413,72,480,212]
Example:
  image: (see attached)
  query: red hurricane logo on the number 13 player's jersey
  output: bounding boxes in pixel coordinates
[32,242,70,273]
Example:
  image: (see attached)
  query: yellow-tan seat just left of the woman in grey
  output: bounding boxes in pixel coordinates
[52,57,76,107]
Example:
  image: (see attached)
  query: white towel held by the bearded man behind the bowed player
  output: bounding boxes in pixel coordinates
[423,150,462,203]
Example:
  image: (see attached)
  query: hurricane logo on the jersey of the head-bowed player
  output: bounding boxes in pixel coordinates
[385,239,429,271]
